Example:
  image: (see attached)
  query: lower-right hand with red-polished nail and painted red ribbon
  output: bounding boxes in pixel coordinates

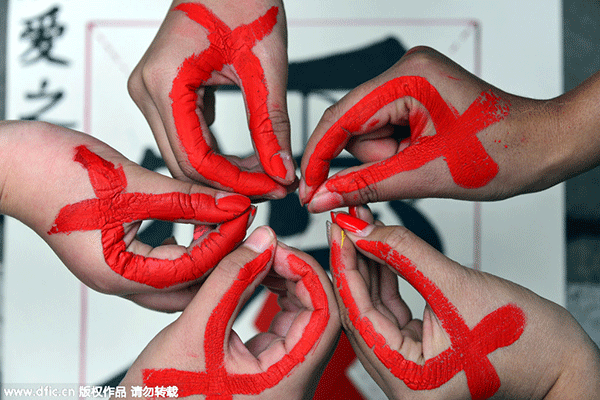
[330,208,600,399]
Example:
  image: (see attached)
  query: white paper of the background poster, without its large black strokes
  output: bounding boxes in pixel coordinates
[1,0,565,398]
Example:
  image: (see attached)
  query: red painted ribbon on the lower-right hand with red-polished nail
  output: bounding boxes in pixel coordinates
[331,240,526,399]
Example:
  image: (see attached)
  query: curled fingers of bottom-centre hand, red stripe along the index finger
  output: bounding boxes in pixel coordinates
[243,243,340,394]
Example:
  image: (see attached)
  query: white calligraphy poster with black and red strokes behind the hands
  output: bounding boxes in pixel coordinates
[0,0,565,399]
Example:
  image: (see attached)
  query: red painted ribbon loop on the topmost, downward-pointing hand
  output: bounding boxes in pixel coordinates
[170,3,286,196]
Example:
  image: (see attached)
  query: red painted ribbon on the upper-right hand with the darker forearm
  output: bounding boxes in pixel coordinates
[304,76,509,193]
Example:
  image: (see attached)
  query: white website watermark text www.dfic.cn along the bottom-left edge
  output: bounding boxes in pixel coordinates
[2,384,179,400]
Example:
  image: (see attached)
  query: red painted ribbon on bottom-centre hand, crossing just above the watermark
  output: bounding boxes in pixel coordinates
[143,253,329,400]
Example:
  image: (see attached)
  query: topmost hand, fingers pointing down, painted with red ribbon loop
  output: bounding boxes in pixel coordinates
[129,0,297,198]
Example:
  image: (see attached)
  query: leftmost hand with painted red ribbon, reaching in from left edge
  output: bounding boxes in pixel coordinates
[0,122,253,311]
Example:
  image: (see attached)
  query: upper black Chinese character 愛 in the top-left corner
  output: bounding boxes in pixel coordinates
[21,6,69,65]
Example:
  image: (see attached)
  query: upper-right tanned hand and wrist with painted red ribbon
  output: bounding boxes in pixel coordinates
[300,48,584,212]
